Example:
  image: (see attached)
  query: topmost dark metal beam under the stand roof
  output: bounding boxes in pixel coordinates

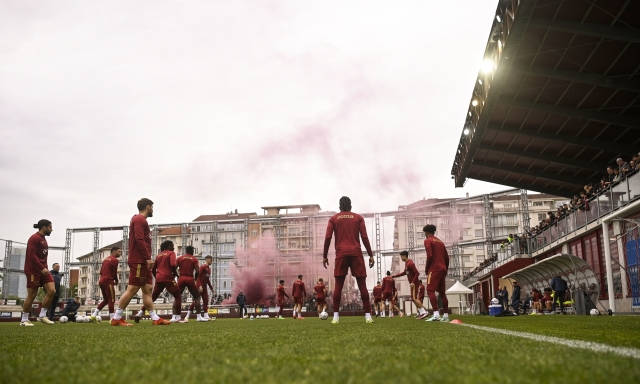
[529,17,640,43]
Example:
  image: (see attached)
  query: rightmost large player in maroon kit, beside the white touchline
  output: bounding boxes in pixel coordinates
[422,224,449,321]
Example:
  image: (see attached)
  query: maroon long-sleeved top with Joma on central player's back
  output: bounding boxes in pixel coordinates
[323,212,373,258]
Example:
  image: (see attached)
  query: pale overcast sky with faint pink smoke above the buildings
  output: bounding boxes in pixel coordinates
[0,0,510,260]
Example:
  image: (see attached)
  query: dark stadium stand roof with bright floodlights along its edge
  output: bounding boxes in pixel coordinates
[451,0,640,197]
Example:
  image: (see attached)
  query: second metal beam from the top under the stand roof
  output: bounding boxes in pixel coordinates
[511,65,640,92]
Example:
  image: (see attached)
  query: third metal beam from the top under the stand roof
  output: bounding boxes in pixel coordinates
[498,96,640,129]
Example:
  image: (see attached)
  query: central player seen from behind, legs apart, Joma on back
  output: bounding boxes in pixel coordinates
[322,196,374,324]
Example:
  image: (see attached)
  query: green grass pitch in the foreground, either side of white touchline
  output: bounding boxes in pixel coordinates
[0,316,640,384]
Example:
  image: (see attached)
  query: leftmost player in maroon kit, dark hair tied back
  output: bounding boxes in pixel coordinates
[20,219,56,327]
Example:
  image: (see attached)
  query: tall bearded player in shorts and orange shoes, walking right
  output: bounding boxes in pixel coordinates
[111,198,164,327]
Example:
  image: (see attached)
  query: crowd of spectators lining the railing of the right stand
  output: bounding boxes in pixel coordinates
[462,152,640,280]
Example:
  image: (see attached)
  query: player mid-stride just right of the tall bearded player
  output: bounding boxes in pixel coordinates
[135,240,179,325]
